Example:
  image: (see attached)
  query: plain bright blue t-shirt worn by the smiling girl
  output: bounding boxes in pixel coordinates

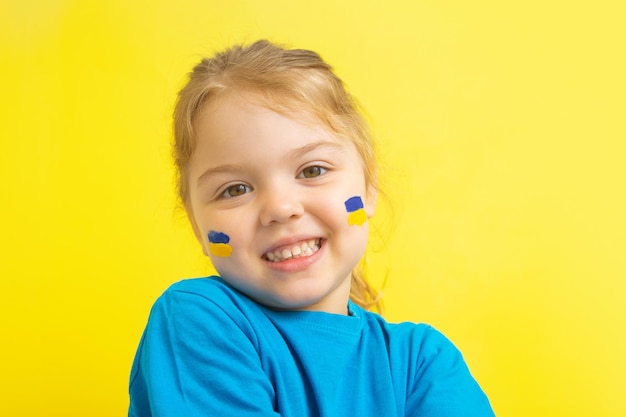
[128,277,493,417]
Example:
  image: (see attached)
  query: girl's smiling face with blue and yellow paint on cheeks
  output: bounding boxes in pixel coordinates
[183,94,376,314]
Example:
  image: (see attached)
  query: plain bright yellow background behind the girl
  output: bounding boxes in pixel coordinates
[0,0,626,417]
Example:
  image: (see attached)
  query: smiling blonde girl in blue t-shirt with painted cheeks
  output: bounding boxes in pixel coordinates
[129,41,493,417]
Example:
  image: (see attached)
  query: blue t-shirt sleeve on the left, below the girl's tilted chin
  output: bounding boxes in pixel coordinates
[128,289,278,417]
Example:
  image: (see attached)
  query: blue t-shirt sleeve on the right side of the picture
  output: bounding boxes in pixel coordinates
[406,326,494,417]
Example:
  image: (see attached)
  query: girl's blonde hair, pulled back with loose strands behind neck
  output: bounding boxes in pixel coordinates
[172,40,382,311]
